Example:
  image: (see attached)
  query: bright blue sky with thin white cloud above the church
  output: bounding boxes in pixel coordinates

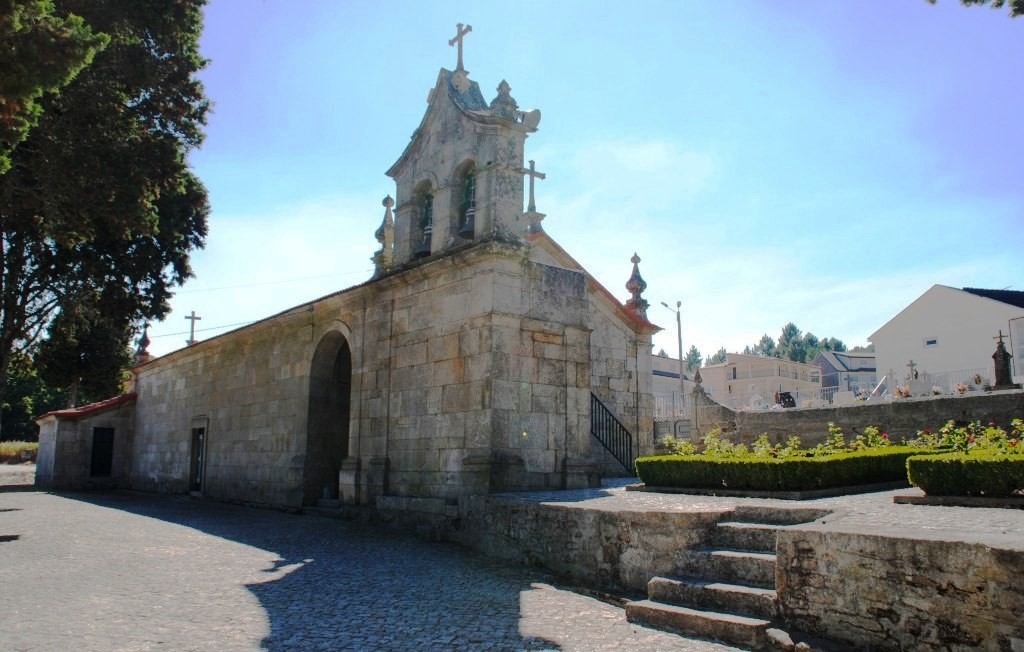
[151,0,1024,355]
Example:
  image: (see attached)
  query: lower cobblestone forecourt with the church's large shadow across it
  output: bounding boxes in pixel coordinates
[0,490,734,652]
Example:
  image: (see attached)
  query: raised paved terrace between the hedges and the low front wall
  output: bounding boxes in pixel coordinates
[498,478,1024,550]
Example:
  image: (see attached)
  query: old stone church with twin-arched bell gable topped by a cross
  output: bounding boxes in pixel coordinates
[37,26,658,507]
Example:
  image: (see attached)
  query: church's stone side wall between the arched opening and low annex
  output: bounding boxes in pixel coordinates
[131,310,315,505]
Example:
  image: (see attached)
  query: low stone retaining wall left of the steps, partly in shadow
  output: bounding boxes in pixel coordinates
[449,496,729,593]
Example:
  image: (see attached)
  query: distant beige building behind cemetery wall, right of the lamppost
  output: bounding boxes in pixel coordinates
[700,353,821,409]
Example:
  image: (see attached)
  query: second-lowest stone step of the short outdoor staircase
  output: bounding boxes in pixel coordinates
[647,577,778,618]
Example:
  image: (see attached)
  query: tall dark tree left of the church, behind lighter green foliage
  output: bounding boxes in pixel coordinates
[0,0,209,429]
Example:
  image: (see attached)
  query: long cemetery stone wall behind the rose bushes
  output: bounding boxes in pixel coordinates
[694,390,1024,446]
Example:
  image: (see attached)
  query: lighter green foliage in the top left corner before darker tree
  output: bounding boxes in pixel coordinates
[0,0,110,174]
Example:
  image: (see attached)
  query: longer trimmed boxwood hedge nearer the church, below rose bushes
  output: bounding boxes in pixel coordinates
[636,446,931,491]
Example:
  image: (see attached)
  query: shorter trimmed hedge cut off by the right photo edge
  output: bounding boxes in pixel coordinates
[906,451,1024,497]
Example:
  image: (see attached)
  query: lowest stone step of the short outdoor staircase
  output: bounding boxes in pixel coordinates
[626,600,772,650]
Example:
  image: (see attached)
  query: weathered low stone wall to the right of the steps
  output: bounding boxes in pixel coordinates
[776,528,1024,650]
